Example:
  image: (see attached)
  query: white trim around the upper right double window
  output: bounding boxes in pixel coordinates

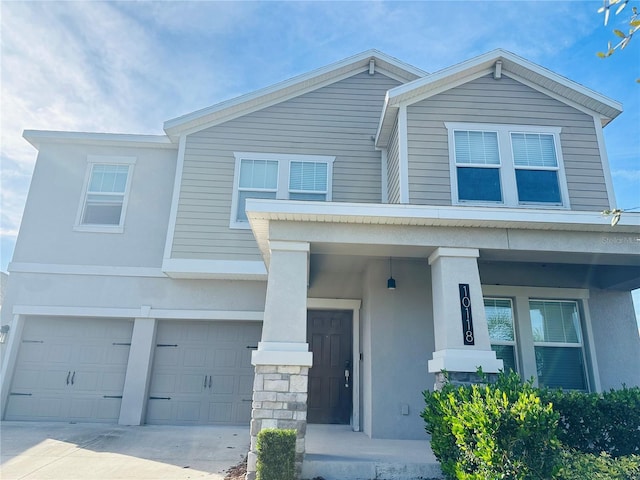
[444,122,570,210]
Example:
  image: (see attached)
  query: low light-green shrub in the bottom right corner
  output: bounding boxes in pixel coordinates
[557,451,640,480]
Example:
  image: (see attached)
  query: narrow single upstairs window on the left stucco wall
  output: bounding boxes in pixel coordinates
[75,156,135,232]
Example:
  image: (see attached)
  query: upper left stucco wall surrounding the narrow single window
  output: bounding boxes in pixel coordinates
[9,144,177,270]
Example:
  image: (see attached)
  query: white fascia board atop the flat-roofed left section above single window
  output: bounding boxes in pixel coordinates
[22,130,178,150]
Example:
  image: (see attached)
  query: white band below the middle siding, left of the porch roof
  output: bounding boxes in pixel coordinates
[162,258,267,281]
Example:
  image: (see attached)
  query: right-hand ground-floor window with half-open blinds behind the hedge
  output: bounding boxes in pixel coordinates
[529,300,587,390]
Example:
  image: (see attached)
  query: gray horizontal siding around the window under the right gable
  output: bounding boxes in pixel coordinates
[407,75,609,211]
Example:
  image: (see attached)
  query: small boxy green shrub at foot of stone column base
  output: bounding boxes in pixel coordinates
[256,428,296,480]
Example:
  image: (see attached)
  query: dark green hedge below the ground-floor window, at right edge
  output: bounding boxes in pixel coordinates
[541,387,640,457]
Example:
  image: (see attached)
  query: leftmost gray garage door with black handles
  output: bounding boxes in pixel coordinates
[5,317,133,422]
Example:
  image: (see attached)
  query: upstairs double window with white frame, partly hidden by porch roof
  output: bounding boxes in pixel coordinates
[230,153,335,228]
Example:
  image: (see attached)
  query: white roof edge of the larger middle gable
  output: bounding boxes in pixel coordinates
[164,49,428,140]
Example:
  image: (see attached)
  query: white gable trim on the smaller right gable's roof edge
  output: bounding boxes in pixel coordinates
[382,49,622,119]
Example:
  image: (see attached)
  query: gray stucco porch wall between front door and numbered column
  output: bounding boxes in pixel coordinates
[362,259,434,439]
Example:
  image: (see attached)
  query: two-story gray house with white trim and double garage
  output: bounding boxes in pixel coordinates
[2,50,640,469]
